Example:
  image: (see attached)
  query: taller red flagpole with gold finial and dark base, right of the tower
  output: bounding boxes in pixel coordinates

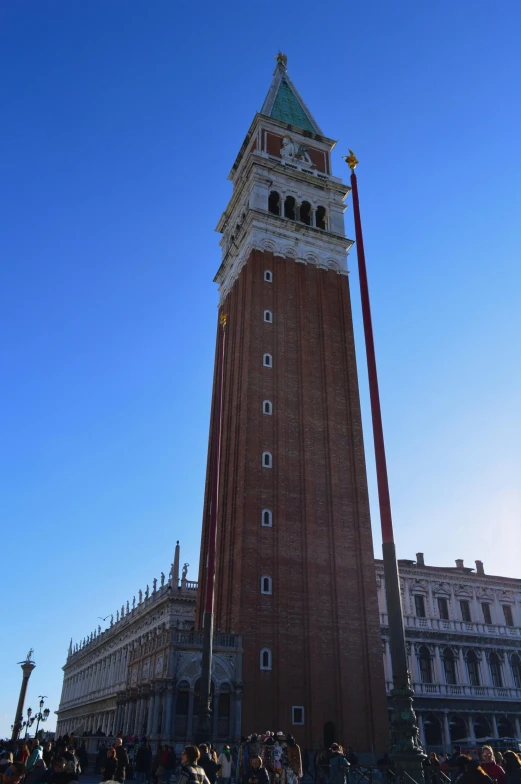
[345,150,426,784]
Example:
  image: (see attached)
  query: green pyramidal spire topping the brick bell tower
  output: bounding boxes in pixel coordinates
[261,52,323,135]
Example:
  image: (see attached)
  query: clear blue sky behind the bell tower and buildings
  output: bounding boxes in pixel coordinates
[0,0,521,735]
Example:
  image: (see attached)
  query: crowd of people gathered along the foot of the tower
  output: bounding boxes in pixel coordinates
[0,732,521,784]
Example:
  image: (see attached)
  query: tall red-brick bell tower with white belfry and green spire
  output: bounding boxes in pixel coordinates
[198,55,388,752]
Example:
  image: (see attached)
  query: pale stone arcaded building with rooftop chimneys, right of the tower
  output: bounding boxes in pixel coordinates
[376,553,521,750]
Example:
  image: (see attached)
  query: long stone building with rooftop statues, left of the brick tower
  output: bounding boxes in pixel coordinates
[56,548,242,744]
